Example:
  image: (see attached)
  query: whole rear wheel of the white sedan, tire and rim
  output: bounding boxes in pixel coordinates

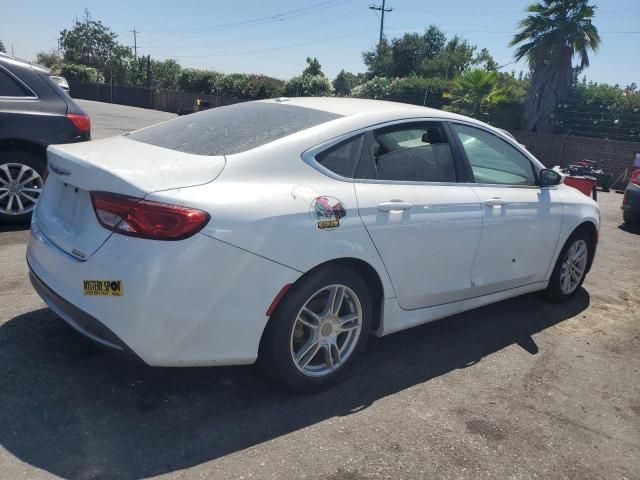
[259,266,373,392]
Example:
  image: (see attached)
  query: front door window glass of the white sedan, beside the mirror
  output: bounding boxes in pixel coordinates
[452,123,536,186]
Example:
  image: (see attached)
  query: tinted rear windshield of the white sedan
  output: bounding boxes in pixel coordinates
[129,102,341,155]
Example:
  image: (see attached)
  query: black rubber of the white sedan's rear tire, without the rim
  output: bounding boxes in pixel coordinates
[258,266,373,392]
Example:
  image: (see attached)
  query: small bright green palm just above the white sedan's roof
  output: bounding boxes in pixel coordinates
[447,70,507,119]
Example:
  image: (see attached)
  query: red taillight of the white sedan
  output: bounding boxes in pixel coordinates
[91,192,209,240]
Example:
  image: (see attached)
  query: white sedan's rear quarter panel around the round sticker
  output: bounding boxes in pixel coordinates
[147,127,395,298]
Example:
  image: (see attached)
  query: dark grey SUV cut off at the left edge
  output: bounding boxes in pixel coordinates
[0,54,91,223]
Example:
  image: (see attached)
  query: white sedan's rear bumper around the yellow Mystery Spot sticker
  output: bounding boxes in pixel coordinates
[27,212,300,366]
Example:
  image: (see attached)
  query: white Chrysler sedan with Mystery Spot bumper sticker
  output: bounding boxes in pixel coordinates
[27,98,600,390]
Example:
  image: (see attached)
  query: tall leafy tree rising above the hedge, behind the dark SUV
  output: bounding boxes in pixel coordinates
[60,10,133,82]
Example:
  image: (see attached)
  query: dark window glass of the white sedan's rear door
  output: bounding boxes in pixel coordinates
[358,122,456,182]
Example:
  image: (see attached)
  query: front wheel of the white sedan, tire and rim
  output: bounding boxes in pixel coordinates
[547,230,592,302]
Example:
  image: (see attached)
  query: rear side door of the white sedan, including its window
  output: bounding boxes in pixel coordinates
[354,121,482,310]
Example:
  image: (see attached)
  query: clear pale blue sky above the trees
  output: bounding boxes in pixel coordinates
[0,0,640,85]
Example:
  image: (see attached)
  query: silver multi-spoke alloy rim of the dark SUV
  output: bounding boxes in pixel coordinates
[0,163,44,215]
